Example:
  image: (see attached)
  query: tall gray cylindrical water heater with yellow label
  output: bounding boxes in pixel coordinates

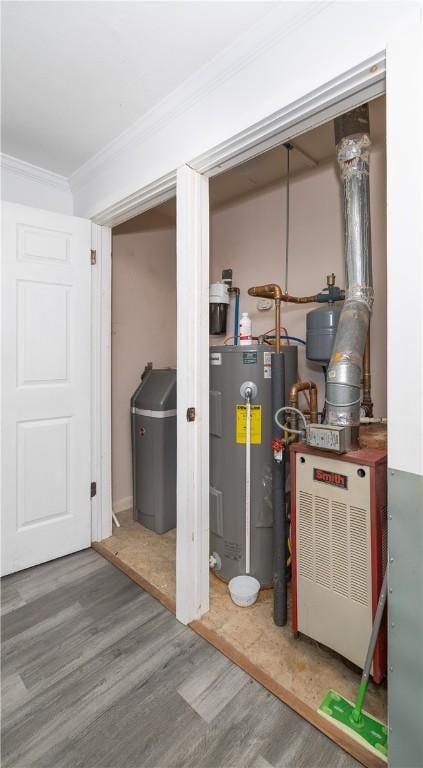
[210,344,297,586]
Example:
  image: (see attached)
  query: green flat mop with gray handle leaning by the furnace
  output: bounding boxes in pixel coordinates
[318,571,388,762]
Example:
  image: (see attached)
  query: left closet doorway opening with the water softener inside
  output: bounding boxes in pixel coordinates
[94,198,177,611]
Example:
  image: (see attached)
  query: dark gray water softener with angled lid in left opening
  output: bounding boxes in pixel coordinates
[131,367,176,533]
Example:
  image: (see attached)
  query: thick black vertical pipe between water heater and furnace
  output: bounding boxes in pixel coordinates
[272,352,287,627]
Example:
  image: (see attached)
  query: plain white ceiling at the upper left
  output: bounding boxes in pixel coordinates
[2,0,274,176]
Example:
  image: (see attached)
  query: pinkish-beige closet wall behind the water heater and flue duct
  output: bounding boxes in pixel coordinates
[211,145,386,416]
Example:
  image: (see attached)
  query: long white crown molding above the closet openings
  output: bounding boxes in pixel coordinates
[70,0,334,192]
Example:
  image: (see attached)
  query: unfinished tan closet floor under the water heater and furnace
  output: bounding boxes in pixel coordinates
[94,511,387,766]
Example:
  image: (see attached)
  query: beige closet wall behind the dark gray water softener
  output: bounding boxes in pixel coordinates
[112,211,176,511]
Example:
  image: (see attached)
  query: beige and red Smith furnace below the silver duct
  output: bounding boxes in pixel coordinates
[291,443,387,682]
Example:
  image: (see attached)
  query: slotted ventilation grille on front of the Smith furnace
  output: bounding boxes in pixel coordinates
[297,490,370,606]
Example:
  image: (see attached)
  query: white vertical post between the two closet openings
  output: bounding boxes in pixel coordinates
[176,165,209,624]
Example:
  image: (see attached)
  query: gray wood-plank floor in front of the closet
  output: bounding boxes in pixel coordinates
[2,550,358,768]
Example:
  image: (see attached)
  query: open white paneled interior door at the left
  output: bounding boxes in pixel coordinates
[2,203,92,574]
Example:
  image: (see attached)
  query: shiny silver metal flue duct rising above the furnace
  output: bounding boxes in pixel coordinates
[326,105,373,442]
